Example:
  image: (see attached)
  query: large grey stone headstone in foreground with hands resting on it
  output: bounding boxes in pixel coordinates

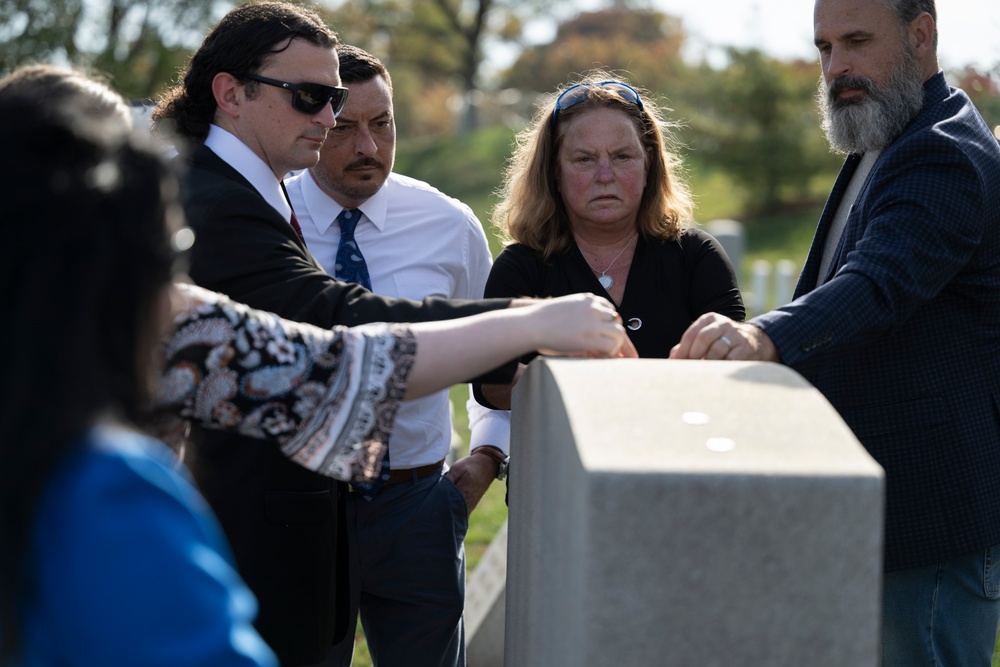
[508,358,884,667]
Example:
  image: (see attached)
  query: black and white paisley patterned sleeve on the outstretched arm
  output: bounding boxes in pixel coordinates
[154,285,416,482]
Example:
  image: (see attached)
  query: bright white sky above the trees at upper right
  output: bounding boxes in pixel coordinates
[532,0,1000,71]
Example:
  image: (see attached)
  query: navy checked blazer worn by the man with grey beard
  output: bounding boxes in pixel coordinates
[753,73,1000,571]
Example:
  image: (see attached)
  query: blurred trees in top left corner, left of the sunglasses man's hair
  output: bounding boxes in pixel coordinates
[0,0,227,98]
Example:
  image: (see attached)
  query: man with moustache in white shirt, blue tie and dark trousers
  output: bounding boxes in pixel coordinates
[286,44,506,667]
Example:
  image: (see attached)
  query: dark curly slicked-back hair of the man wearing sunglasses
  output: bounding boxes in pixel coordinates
[153,2,337,143]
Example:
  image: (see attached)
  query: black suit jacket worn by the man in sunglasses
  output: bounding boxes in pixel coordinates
[176,146,514,665]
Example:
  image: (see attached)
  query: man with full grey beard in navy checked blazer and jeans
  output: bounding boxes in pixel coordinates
[671,0,1000,667]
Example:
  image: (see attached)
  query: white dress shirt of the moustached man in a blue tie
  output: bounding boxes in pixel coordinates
[285,171,509,469]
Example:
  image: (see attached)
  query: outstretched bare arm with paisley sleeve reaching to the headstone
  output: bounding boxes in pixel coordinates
[153,285,628,480]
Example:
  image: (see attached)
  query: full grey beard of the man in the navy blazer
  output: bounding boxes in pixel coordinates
[816,50,924,154]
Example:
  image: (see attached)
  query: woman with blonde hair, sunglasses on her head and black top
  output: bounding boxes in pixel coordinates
[476,70,745,408]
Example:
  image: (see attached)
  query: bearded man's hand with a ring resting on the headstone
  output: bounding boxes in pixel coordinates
[670,313,781,361]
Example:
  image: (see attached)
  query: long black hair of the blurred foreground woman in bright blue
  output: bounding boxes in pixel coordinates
[0,75,179,662]
